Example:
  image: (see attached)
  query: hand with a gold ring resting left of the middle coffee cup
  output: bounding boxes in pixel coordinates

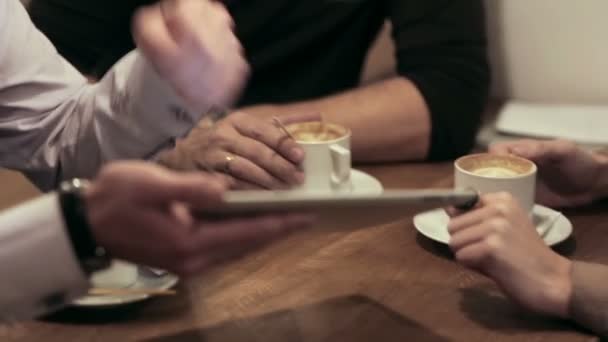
[161,112,319,190]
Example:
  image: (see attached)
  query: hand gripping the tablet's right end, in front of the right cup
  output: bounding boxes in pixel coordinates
[448,193,572,317]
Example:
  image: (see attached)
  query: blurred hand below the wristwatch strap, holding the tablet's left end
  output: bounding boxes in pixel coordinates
[85,162,311,276]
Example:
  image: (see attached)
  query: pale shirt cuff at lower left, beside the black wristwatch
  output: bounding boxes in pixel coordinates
[0,194,89,320]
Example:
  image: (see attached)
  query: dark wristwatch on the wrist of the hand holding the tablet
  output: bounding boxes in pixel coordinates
[58,178,112,275]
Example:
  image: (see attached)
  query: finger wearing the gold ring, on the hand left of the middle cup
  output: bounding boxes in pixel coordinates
[205,150,289,190]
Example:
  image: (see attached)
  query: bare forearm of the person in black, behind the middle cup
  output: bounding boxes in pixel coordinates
[243,77,431,162]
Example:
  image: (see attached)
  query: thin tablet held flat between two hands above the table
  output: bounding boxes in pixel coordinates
[201,189,478,234]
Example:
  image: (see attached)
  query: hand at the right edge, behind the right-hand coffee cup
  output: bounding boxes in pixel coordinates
[490,140,606,207]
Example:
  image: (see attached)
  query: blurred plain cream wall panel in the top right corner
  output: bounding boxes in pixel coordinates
[486,0,608,104]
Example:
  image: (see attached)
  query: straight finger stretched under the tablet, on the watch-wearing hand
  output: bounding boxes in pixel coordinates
[193,214,313,251]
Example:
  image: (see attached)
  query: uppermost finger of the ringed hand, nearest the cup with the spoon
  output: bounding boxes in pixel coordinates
[234,115,304,165]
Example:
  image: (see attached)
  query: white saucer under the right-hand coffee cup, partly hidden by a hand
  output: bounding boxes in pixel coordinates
[414,204,572,246]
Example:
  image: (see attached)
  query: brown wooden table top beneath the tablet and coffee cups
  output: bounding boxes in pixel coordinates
[0,163,608,342]
